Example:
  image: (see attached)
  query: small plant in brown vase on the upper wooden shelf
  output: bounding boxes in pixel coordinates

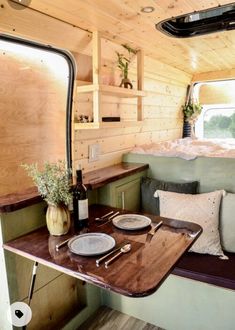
[116,45,137,89]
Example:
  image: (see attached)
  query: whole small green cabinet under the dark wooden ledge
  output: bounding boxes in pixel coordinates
[98,171,146,211]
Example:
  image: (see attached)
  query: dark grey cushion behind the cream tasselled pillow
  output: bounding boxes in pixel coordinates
[141,177,198,215]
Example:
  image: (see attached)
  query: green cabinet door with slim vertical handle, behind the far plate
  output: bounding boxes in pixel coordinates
[115,178,140,211]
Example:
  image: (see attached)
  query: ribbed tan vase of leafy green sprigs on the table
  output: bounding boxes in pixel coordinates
[22,161,72,236]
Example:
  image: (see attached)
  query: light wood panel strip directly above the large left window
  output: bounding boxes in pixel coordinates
[0,0,91,53]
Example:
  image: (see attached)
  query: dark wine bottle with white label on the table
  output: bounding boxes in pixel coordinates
[73,167,88,229]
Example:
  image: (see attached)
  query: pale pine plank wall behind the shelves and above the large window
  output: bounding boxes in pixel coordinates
[0,0,191,179]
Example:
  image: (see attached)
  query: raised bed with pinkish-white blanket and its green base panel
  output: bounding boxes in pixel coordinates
[123,138,235,193]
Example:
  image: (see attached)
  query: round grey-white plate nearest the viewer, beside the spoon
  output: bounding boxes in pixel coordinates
[68,233,116,256]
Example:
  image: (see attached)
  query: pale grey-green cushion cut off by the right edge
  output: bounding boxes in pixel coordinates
[219,193,235,252]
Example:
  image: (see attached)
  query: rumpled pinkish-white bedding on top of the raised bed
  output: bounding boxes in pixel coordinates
[131,138,235,160]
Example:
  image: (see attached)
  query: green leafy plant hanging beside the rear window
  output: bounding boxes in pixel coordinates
[182,100,202,137]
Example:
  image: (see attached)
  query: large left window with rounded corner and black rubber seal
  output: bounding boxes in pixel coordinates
[0,34,74,195]
